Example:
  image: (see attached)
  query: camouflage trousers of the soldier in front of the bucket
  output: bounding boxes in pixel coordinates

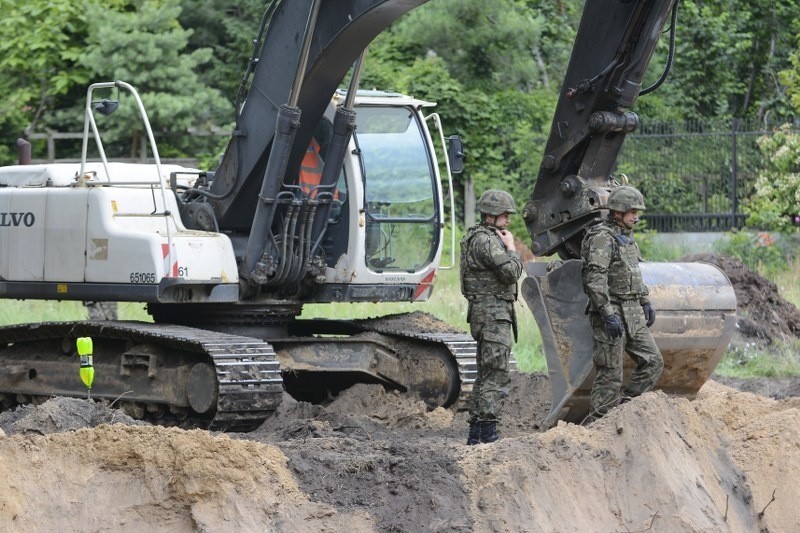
[589,304,664,417]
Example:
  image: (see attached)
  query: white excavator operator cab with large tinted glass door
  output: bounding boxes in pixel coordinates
[316,90,454,301]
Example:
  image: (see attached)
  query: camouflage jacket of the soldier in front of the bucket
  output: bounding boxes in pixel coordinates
[581,219,650,317]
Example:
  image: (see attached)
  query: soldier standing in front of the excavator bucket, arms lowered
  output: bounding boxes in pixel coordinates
[581,185,664,422]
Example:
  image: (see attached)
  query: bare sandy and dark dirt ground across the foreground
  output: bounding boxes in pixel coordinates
[0,260,800,533]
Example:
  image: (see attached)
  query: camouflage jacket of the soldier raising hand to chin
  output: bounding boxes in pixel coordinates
[460,224,522,321]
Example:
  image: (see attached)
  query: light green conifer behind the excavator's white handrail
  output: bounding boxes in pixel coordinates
[60,0,232,159]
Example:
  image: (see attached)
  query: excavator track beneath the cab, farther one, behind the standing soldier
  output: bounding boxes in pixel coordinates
[272,311,477,409]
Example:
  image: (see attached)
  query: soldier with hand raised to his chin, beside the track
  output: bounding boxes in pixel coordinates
[460,189,522,445]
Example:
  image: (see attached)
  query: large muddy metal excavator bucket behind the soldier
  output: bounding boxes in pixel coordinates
[522,259,736,428]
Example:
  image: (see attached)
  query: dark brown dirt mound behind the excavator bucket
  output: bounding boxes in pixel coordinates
[680,254,800,342]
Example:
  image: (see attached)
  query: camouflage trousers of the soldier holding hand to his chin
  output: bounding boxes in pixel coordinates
[469,321,512,423]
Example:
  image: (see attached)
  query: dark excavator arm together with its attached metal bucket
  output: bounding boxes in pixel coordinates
[522,0,736,427]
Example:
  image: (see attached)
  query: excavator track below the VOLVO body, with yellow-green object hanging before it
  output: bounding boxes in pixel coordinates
[0,321,283,431]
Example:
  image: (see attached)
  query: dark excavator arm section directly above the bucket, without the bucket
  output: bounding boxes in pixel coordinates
[522,0,677,258]
